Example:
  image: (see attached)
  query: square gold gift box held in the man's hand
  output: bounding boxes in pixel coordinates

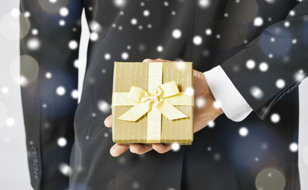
[112,62,194,145]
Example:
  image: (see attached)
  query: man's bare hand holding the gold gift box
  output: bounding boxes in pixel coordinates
[104,59,223,157]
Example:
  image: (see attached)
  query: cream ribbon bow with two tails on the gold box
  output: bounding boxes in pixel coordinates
[118,81,188,121]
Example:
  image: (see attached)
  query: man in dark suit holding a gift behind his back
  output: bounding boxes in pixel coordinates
[21,0,308,190]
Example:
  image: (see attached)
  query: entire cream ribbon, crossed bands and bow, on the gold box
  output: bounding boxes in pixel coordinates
[113,62,193,141]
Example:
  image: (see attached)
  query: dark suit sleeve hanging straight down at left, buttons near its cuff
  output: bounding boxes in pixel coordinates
[20,0,83,190]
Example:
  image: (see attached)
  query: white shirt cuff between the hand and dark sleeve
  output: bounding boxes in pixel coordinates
[203,65,252,122]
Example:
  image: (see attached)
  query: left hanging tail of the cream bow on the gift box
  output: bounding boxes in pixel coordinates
[118,104,150,121]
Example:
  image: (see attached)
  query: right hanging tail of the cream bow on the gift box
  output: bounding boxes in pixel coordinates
[156,101,188,120]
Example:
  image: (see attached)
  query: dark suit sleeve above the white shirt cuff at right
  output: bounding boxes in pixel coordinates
[222,0,308,118]
